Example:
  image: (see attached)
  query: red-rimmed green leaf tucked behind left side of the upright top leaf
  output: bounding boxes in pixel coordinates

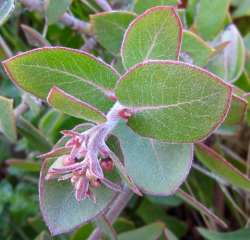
[90,11,137,53]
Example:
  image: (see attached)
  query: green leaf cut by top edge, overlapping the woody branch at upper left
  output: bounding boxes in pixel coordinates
[44,0,73,25]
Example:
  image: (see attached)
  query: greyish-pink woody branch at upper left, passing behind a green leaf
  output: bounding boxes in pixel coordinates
[18,0,91,34]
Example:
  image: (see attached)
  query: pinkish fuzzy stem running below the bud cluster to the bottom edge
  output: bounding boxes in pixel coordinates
[88,186,134,240]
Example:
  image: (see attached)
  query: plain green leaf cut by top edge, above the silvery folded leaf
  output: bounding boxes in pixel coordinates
[194,0,229,41]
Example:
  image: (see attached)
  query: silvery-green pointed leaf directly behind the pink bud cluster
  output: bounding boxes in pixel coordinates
[39,158,121,235]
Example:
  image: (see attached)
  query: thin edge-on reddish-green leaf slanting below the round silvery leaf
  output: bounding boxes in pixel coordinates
[175,189,227,228]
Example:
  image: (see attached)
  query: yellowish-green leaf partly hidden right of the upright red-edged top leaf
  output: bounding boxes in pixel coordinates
[180,30,214,67]
